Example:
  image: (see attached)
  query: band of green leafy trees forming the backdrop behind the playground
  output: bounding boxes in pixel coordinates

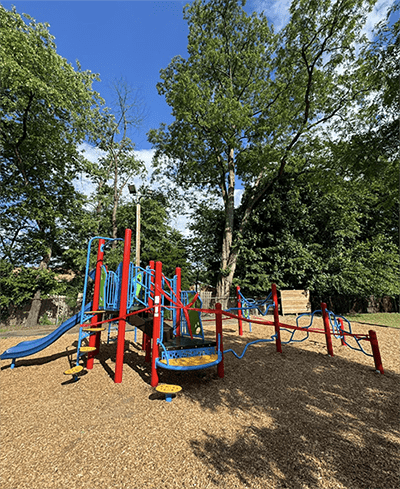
[0,0,400,324]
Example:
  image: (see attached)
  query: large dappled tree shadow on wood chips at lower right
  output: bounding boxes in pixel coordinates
[92,332,400,489]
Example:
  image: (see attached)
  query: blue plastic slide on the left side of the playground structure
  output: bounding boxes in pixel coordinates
[0,302,92,367]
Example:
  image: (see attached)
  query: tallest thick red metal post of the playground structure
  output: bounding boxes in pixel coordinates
[114,229,132,384]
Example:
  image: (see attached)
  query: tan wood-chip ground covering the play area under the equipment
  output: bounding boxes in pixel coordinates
[0,317,400,489]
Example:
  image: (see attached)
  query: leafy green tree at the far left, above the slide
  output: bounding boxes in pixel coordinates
[0,5,100,325]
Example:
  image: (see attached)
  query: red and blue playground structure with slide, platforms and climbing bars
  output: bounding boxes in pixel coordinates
[1,229,384,387]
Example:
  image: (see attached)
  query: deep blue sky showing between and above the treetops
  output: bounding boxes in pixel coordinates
[0,0,392,150]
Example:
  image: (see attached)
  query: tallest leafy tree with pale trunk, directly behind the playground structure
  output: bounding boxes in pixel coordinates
[149,0,374,304]
